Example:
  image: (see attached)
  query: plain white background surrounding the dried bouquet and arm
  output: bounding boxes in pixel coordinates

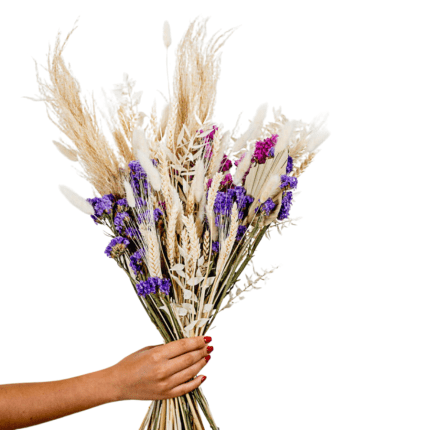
[0,0,430,430]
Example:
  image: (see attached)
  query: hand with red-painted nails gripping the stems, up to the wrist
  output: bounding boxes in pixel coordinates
[110,336,213,400]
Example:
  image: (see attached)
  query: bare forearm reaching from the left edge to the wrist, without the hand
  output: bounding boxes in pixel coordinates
[0,368,117,430]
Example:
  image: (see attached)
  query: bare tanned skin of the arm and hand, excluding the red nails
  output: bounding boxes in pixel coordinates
[0,336,209,430]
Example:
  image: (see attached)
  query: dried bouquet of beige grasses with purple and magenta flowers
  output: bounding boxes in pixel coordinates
[29,19,328,430]
